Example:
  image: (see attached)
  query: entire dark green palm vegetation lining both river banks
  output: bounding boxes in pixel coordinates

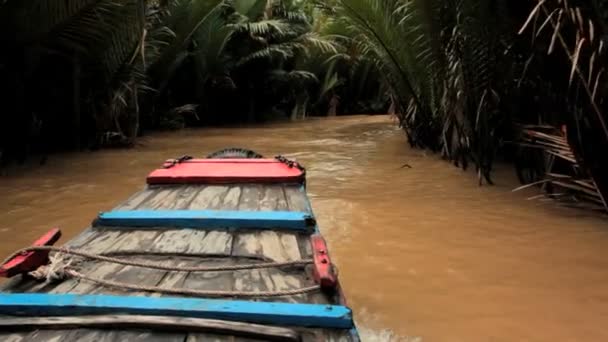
[0,0,608,211]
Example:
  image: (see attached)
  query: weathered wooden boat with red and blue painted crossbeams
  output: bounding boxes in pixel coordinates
[0,150,359,342]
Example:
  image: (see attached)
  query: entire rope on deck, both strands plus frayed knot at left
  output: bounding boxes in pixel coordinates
[2,246,320,297]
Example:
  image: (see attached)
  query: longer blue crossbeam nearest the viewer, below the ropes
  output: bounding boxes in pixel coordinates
[0,293,354,329]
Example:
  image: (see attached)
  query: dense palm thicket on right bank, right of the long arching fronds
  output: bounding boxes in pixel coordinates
[334,0,608,209]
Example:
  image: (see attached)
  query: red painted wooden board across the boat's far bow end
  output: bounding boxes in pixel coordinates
[147,159,304,184]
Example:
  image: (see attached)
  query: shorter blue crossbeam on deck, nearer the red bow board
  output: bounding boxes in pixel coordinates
[93,210,314,231]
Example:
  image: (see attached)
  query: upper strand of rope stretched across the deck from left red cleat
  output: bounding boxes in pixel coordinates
[0,246,313,272]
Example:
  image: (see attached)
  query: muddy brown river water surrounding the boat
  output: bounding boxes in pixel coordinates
[0,116,608,341]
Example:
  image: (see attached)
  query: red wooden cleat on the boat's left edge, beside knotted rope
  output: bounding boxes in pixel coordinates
[0,228,61,278]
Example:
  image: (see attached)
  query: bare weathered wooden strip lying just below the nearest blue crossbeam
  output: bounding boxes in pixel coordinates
[0,315,299,341]
